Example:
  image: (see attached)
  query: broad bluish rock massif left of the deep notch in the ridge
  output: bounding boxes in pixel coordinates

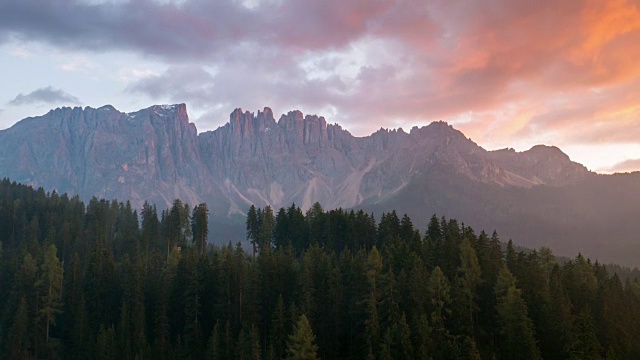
[0,104,206,210]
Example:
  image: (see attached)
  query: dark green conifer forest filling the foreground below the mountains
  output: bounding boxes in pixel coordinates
[0,179,640,360]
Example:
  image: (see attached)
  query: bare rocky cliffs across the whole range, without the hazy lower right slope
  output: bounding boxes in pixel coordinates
[0,104,589,215]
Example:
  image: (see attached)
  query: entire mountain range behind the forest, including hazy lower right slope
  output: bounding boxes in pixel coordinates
[0,104,640,265]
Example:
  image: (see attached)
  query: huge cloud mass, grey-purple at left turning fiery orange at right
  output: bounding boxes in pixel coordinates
[0,0,640,146]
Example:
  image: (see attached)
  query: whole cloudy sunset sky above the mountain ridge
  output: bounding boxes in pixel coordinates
[0,0,640,172]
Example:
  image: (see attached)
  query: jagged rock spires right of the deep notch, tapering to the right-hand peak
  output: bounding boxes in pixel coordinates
[198,108,589,212]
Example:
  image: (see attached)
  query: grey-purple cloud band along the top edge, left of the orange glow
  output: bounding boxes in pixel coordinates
[0,0,396,60]
